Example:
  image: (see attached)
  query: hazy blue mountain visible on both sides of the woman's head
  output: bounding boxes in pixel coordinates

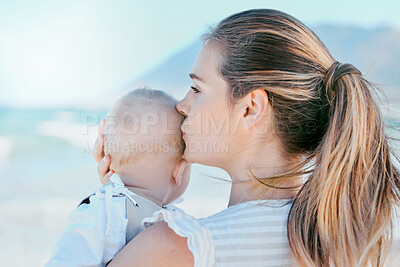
[135,25,400,102]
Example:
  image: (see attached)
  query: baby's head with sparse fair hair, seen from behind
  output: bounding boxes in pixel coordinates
[104,89,190,205]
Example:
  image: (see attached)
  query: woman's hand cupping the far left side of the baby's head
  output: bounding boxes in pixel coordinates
[92,119,113,184]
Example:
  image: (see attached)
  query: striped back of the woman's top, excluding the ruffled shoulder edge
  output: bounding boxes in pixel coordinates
[205,200,294,266]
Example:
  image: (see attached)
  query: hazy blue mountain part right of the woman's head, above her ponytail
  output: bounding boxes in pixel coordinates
[314,25,400,88]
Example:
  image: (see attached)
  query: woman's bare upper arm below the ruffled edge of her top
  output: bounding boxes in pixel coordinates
[108,222,194,267]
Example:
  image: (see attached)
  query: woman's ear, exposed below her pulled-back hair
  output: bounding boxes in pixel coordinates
[242,89,269,129]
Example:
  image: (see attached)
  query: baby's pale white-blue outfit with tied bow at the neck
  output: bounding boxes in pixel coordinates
[45,173,177,267]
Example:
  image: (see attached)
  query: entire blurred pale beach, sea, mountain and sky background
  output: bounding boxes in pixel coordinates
[0,0,400,266]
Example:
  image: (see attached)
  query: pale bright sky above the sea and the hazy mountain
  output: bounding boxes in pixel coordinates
[0,0,400,108]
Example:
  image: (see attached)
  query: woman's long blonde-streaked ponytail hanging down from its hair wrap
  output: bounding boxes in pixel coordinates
[287,62,400,266]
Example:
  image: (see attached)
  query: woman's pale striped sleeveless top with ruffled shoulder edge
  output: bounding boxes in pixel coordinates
[143,200,295,267]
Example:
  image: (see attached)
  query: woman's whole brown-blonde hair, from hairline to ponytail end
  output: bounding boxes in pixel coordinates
[205,9,400,266]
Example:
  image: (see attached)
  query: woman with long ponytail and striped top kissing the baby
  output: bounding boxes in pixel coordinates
[93,9,400,266]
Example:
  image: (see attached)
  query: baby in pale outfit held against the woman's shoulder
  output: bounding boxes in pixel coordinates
[46,89,190,266]
